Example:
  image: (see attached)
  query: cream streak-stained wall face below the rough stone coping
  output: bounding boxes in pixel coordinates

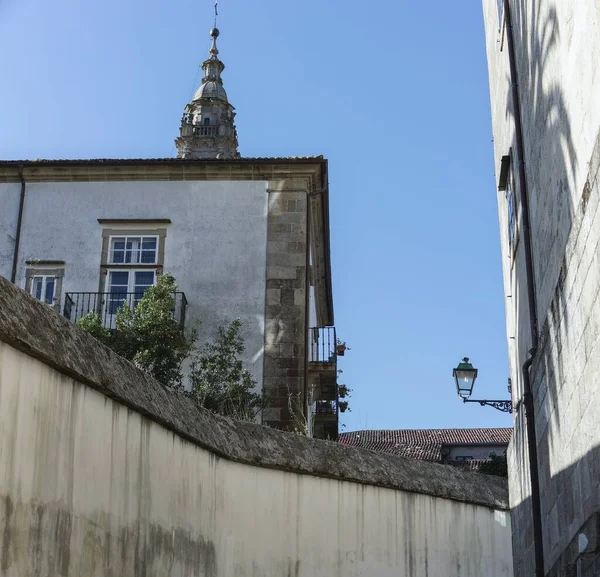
[0,343,512,577]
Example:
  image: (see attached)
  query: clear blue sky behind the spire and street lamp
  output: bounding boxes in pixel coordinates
[0,0,510,430]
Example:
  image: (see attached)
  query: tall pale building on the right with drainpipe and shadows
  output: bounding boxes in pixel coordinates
[483,0,600,577]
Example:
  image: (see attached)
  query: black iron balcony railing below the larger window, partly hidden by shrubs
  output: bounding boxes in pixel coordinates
[63,292,187,329]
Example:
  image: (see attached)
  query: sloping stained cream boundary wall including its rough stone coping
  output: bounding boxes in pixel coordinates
[0,278,512,577]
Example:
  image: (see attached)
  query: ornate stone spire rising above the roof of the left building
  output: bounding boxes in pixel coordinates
[175,28,240,158]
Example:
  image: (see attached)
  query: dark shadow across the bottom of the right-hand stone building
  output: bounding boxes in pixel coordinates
[511,432,600,577]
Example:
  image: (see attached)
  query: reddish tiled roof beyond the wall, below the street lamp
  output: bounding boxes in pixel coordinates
[338,428,512,461]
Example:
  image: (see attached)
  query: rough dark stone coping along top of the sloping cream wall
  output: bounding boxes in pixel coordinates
[0,276,509,510]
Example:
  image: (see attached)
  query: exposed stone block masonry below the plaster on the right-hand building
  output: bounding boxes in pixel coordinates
[510,128,600,577]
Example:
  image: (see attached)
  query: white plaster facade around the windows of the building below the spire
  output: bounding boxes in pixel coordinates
[0,181,267,383]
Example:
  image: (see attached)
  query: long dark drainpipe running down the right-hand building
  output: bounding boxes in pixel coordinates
[504,0,545,577]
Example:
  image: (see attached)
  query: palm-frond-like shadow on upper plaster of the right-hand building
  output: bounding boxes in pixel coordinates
[507,1,577,436]
